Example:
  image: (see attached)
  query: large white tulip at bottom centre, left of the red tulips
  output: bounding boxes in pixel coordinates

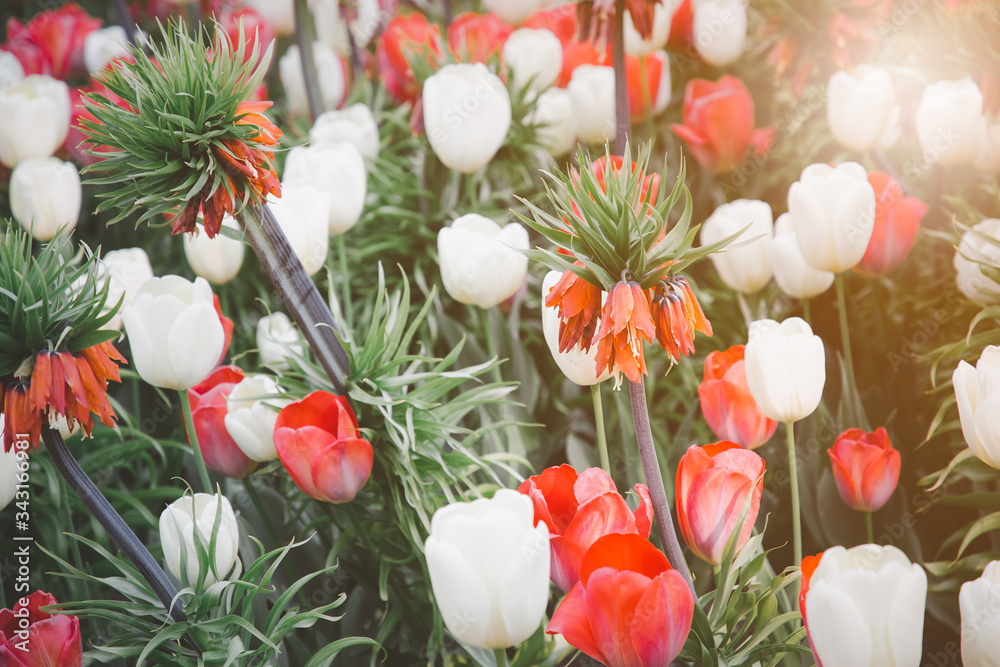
[424,489,550,649]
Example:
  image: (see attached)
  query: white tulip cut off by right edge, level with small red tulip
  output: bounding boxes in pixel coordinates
[951,345,1000,469]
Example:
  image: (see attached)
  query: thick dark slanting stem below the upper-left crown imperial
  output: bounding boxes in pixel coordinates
[238,204,350,394]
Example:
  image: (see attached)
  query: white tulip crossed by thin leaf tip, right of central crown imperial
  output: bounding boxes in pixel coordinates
[701,199,774,294]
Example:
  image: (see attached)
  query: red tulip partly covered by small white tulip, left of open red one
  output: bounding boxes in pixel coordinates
[188,366,257,479]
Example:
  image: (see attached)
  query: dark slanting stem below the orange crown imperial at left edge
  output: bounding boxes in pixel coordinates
[42,424,187,621]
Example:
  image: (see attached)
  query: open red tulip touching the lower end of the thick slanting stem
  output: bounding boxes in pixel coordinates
[274,391,374,503]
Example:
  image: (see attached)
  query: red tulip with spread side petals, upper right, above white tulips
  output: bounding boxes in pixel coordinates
[670,75,775,174]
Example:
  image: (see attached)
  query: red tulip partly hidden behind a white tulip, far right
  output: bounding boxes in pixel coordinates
[855,171,927,276]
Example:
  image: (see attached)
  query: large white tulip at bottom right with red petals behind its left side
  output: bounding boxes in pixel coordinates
[805,544,927,667]
